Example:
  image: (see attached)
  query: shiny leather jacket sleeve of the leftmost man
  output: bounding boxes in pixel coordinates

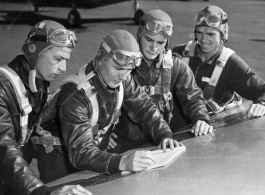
[0,86,51,195]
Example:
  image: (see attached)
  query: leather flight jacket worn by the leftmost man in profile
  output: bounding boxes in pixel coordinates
[0,55,51,195]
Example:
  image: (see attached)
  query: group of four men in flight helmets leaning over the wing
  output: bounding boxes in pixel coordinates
[0,6,265,195]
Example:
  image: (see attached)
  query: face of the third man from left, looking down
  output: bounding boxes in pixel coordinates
[140,33,167,60]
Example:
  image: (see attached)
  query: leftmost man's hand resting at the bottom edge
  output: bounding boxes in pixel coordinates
[51,185,92,195]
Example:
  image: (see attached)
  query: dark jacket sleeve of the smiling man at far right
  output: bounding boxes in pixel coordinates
[225,54,265,105]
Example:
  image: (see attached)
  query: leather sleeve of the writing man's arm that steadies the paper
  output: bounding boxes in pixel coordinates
[123,75,172,144]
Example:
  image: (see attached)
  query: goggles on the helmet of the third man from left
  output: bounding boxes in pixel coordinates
[140,20,174,37]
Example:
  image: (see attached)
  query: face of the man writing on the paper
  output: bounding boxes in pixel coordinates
[99,58,134,88]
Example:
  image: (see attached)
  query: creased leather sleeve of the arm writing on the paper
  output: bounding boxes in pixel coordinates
[58,84,122,173]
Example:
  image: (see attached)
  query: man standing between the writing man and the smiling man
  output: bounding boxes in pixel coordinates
[108,10,212,153]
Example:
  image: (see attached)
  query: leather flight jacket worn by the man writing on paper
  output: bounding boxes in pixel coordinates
[49,62,172,174]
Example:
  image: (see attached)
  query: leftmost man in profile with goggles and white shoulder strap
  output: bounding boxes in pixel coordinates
[0,21,91,195]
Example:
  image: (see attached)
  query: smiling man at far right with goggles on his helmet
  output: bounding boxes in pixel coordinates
[173,5,265,119]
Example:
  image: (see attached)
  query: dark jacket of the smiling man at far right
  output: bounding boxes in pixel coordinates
[173,44,265,107]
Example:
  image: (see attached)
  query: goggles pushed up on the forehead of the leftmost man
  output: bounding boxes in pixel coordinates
[49,29,77,47]
